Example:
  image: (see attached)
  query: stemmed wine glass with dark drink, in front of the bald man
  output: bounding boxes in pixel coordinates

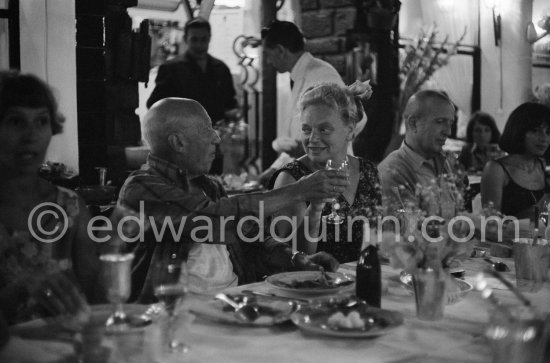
[153,254,189,353]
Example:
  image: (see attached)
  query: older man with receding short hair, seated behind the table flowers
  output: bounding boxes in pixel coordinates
[378,90,462,215]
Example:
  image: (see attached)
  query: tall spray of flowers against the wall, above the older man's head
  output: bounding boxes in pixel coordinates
[395,24,466,130]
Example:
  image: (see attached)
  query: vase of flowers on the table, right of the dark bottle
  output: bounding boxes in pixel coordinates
[380,175,472,320]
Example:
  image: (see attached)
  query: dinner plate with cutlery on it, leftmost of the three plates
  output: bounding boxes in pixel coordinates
[190,294,297,327]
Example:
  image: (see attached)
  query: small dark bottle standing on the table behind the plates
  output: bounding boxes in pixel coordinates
[355,245,382,308]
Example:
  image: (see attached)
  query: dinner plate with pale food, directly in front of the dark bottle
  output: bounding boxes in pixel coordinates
[291,304,403,338]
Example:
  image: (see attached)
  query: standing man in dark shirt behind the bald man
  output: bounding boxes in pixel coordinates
[147,18,240,174]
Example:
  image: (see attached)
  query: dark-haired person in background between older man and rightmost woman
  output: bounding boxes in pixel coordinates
[458,111,503,172]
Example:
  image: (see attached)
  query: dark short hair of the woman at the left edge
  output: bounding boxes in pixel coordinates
[0,71,65,135]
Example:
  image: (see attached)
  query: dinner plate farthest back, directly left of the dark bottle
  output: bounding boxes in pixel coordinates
[265,271,355,295]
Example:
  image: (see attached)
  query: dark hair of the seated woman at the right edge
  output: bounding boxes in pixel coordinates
[499,102,550,154]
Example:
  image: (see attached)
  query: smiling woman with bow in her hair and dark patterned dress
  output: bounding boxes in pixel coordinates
[270,82,381,262]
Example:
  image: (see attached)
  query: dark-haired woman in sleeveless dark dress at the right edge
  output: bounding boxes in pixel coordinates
[481,102,550,219]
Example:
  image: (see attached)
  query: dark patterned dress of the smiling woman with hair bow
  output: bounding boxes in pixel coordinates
[270,158,382,263]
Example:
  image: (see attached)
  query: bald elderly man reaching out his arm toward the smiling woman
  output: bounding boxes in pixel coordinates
[119,98,348,302]
